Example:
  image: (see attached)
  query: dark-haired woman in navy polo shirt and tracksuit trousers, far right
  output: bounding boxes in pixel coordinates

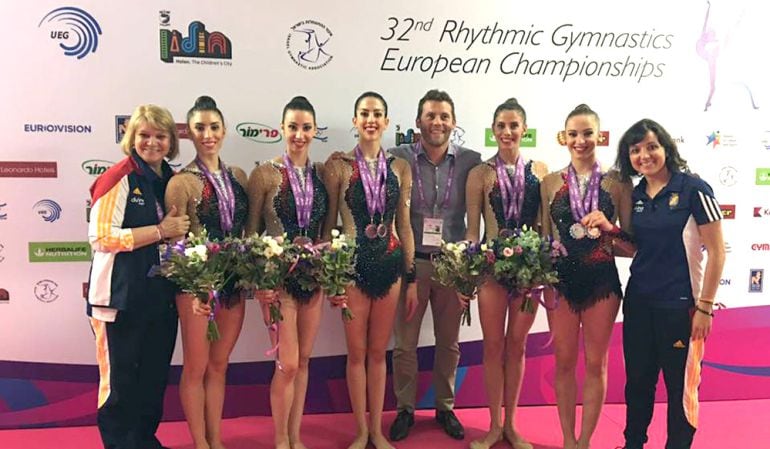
[616,119,725,449]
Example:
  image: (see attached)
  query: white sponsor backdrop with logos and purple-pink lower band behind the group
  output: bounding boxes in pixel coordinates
[0,0,770,427]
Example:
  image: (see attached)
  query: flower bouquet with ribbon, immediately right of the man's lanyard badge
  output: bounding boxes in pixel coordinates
[433,241,495,326]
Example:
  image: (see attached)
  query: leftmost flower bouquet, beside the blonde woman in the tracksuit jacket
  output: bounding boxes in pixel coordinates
[148,229,230,341]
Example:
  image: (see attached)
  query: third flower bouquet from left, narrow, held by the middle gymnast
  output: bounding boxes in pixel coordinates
[317,229,356,321]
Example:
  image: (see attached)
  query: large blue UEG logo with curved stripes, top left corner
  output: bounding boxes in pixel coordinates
[37,6,102,59]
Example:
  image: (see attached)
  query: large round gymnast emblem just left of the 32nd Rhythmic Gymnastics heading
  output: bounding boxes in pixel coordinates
[286,20,334,70]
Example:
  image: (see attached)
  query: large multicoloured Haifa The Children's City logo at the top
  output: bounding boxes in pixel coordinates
[160,11,233,66]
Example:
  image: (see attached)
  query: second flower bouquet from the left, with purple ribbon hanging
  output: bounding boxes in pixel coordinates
[233,234,293,324]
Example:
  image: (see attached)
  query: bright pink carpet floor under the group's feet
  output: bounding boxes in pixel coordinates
[0,399,770,449]
